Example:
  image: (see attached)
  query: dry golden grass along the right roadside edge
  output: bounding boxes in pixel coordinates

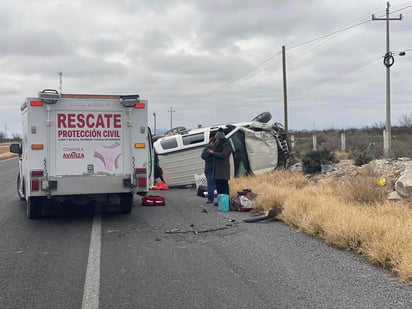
[230,169,412,283]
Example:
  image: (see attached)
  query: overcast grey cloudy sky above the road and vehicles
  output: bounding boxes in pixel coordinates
[0,0,412,136]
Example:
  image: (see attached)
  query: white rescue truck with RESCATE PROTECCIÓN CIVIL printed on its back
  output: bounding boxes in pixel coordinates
[10,89,153,219]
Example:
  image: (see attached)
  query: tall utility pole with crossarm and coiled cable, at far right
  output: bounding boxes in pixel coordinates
[372,2,402,157]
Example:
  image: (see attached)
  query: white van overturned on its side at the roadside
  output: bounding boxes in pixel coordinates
[153,112,291,187]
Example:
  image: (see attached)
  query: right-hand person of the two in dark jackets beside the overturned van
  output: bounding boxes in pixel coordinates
[208,128,232,194]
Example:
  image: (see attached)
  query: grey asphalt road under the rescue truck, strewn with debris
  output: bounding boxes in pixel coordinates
[0,159,412,309]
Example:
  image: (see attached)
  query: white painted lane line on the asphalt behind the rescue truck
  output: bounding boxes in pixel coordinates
[82,205,102,309]
